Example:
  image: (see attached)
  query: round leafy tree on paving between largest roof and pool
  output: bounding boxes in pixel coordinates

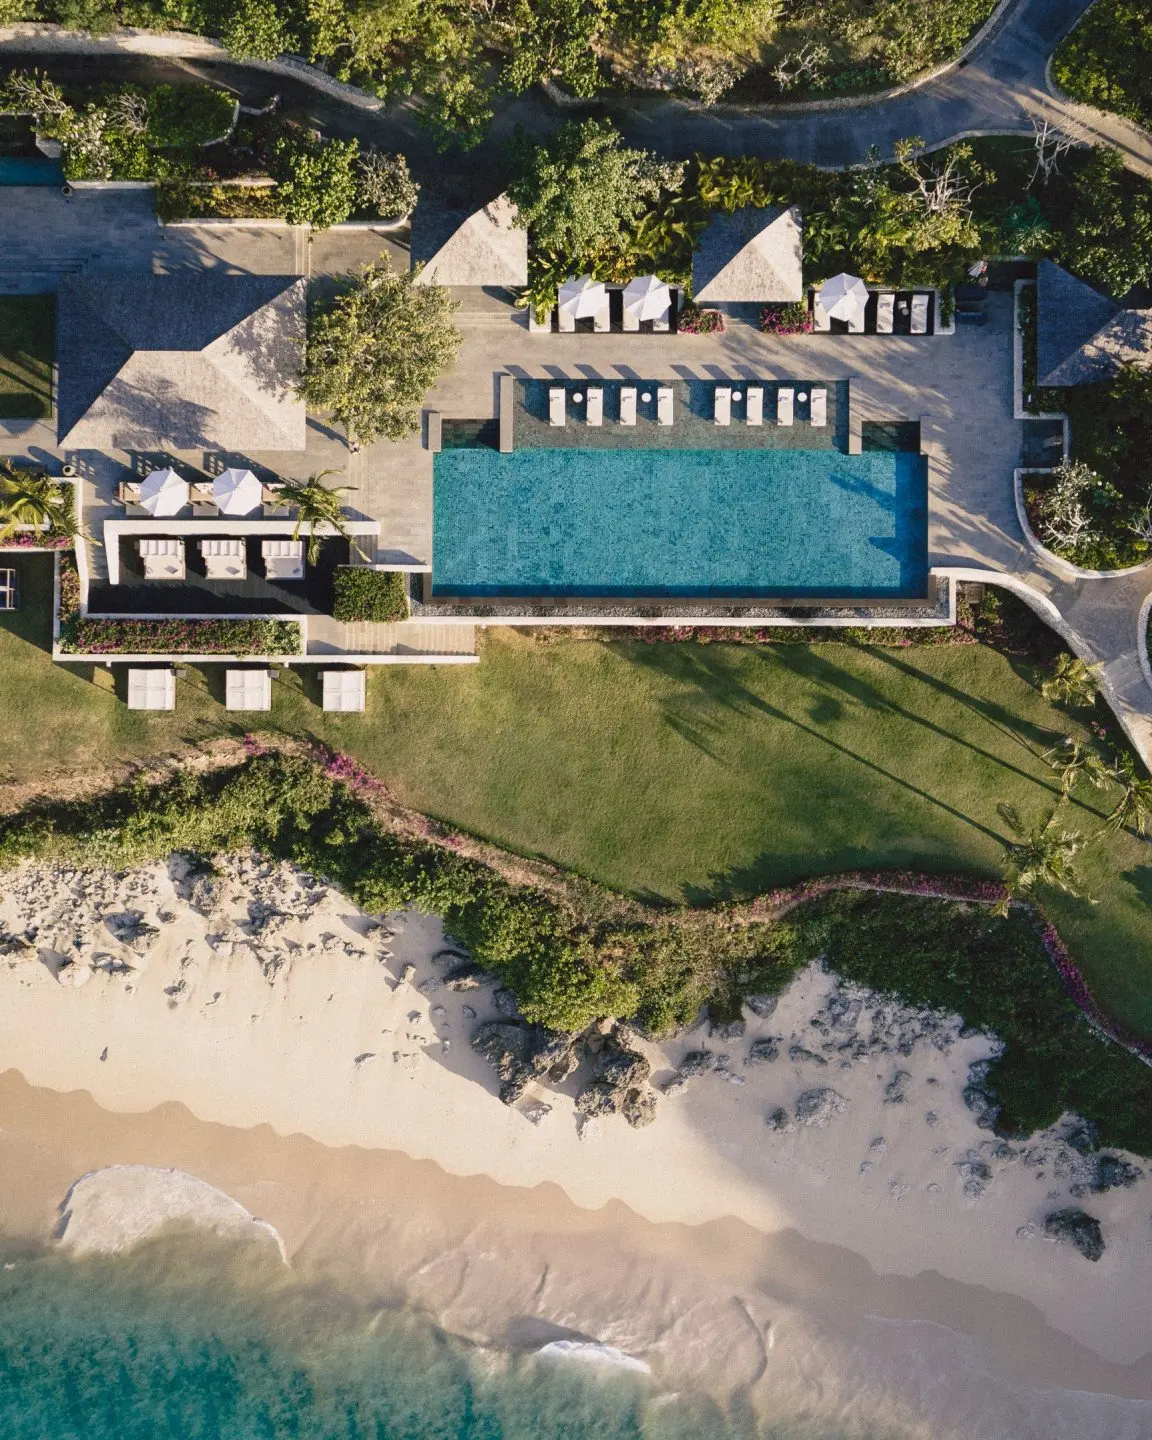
[300,265,461,451]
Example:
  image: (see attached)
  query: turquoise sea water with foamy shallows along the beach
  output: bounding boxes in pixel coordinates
[0,1240,892,1440]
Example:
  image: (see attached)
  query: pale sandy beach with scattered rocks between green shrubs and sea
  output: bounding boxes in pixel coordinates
[0,857,1152,1440]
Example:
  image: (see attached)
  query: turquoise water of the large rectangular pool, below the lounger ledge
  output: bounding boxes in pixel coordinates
[432,449,927,599]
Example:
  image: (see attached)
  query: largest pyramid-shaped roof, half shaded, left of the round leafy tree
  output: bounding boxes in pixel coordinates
[56,271,305,451]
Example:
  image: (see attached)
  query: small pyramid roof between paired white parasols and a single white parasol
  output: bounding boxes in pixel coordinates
[693,206,804,304]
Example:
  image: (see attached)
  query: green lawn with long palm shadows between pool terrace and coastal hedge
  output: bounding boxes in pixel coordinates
[0,581,1152,1034]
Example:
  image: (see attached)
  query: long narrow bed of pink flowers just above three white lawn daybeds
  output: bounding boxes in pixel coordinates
[60,606,300,655]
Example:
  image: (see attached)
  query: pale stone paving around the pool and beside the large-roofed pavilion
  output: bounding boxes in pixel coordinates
[0,207,1152,762]
